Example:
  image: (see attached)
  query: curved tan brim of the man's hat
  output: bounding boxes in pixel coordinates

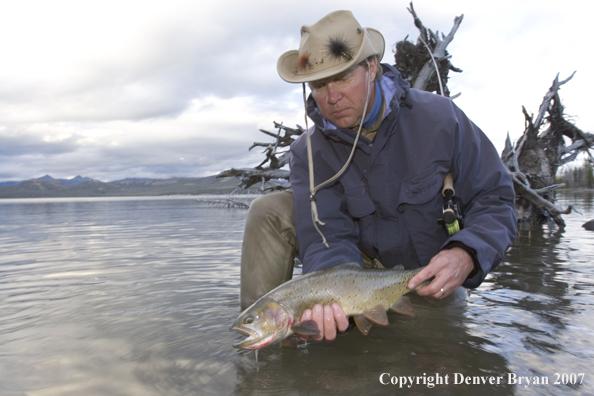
[276,28,386,83]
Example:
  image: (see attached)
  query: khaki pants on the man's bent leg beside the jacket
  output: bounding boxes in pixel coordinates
[240,191,384,309]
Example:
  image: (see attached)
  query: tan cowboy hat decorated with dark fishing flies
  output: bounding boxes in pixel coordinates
[276,11,386,83]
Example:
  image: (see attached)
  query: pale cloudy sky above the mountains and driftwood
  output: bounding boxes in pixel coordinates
[0,0,594,181]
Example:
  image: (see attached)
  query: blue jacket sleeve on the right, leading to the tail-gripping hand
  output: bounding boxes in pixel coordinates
[442,104,516,288]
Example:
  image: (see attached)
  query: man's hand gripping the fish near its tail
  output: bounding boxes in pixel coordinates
[408,247,474,300]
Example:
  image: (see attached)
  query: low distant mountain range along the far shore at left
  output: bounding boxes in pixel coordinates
[0,176,238,198]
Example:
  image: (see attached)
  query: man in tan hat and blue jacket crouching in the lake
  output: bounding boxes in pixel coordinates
[241,11,516,340]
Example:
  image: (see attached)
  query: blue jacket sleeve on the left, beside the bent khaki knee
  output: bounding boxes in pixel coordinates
[290,132,363,273]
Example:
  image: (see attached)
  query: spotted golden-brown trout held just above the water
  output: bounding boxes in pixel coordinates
[231,263,429,349]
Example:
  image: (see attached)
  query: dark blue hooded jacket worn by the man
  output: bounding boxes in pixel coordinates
[290,64,516,288]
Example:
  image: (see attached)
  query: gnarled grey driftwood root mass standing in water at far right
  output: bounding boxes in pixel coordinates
[501,72,594,228]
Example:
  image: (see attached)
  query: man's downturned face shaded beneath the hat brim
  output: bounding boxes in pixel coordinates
[309,58,377,128]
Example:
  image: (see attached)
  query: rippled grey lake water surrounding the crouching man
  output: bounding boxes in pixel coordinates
[0,194,594,396]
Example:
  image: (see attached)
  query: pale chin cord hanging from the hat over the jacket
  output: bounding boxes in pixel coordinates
[303,60,371,248]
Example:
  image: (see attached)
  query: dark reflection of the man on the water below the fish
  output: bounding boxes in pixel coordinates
[236,298,511,395]
